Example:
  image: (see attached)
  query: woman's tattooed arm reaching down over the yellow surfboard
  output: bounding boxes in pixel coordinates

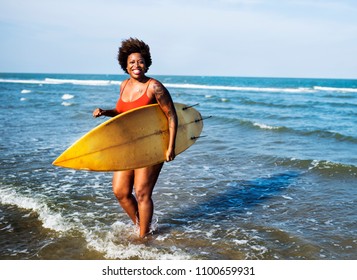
[153,80,178,161]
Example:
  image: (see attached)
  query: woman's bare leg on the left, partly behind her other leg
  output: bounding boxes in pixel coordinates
[113,170,138,224]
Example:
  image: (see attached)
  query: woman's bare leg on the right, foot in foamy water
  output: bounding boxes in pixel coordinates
[134,163,163,237]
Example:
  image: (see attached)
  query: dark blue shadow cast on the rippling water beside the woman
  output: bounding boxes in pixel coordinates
[170,172,299,221]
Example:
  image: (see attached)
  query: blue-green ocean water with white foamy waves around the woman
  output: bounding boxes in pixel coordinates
[0,73,357,259]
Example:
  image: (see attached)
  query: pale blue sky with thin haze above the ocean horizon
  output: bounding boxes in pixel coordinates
[0,0,357,78]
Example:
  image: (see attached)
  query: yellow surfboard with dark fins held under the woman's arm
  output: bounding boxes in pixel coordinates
[53,103,203,171]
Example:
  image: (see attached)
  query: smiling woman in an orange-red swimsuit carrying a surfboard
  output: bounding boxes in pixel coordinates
[93,38,177,237]
